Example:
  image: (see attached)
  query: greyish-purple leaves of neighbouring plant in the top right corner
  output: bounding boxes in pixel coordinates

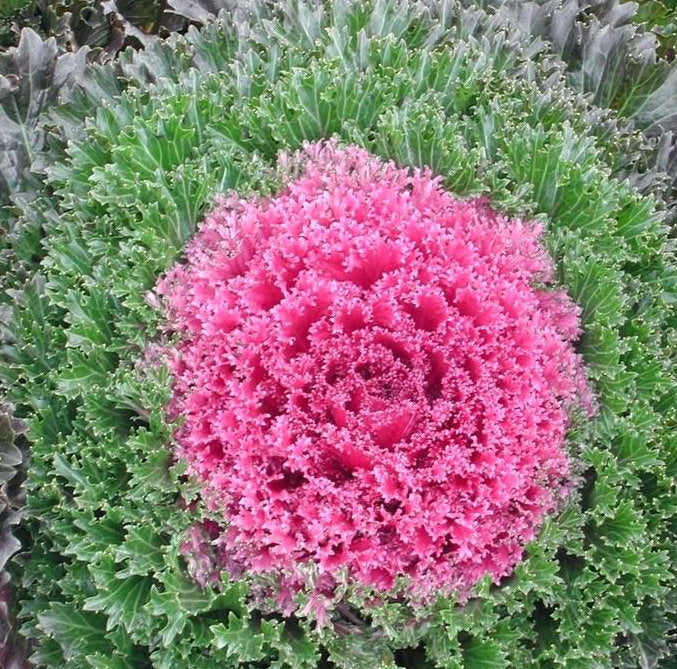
[481,0,677,214]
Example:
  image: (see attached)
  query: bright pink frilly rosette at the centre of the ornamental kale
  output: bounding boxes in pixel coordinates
[159,142,587,592]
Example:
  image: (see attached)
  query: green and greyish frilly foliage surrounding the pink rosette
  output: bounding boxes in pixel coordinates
[0,0,677,669]
